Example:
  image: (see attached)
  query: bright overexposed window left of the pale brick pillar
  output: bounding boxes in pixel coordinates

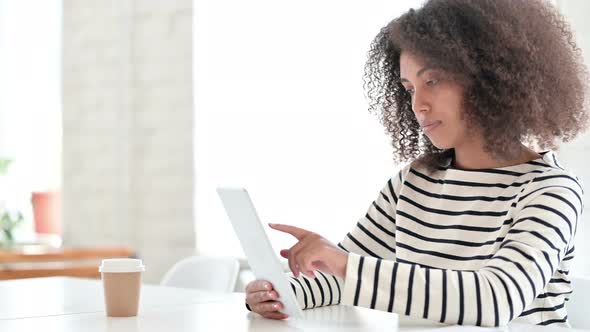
[0,0,62,240]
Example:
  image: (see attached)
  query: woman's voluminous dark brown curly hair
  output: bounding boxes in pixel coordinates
[363,0,589,169]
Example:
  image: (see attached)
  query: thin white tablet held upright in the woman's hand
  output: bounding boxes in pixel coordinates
[217,187,302,318]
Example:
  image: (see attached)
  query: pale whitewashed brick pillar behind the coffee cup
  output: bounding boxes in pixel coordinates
[63,0,195,282]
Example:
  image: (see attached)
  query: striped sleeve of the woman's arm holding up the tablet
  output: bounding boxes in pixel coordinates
[288,170,403,309]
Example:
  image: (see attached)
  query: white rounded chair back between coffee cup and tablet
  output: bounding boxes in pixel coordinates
[160,256,240,292]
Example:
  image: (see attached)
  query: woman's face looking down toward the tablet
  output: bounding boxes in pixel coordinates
[400,52,468,149]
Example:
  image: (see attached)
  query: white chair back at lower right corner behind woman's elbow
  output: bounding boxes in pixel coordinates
[566,277,590,329]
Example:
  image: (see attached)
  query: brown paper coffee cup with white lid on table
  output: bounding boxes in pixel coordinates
[98,258,145,317]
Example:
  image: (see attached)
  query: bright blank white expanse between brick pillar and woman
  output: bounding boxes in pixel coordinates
[194,0,421,255]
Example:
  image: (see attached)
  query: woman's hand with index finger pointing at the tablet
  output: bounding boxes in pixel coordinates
[268,224,348,278]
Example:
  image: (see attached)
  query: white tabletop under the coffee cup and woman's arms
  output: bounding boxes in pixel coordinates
[0,277,588,332]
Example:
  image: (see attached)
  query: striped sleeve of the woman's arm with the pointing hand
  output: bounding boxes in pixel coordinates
[341,170,583,326]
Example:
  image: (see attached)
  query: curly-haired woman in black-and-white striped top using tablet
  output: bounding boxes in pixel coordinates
[246,0,588,326]
